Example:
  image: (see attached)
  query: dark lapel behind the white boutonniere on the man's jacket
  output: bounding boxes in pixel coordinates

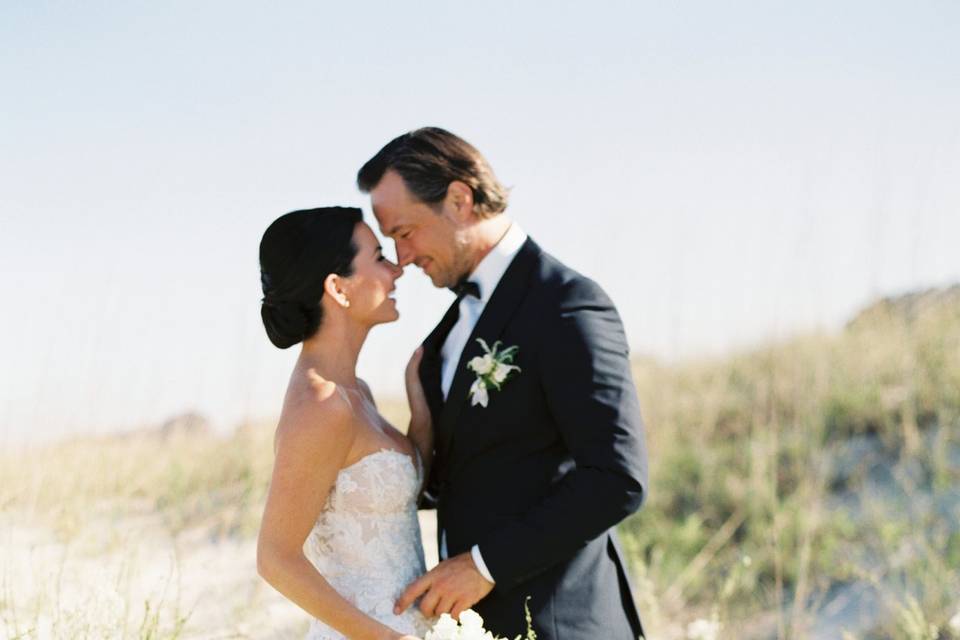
[437,238,540,456]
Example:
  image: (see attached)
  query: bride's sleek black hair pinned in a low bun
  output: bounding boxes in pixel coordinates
[260,207,363,349]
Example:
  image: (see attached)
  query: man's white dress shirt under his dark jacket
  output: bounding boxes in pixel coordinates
[440,222,527,582]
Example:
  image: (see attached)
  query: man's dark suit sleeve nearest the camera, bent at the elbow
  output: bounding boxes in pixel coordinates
[479,279,647,589]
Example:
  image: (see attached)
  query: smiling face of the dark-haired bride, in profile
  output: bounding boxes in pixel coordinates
[344,222,403,326]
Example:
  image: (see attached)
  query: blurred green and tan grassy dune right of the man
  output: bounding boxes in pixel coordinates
[620,287,960,638]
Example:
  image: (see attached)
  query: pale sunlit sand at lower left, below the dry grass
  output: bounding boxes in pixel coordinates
[0,511,436,640]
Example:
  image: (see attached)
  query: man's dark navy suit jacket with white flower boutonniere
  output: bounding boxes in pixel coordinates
[420,239,647,640]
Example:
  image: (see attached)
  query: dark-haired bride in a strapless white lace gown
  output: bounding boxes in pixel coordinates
[257,207,433,640]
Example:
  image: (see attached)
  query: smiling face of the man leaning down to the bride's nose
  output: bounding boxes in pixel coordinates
[370,170,471,287]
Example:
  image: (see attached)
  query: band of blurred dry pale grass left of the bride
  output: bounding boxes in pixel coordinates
[0,425,273,541]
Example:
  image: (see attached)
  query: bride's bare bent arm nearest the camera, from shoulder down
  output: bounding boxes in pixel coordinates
[257,373,415,640]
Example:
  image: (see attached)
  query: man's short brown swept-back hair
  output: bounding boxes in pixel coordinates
[357,127,508,218]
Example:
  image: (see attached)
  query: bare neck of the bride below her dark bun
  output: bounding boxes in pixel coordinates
[296,316,370,387]
